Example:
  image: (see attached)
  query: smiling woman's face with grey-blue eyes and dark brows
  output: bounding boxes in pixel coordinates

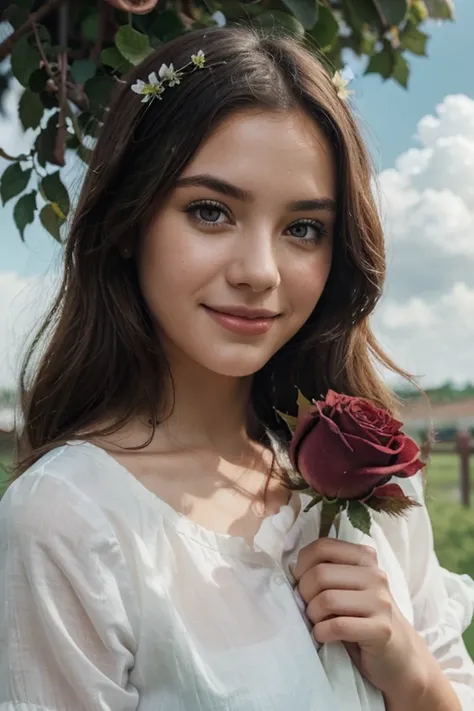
[138,110,336,377]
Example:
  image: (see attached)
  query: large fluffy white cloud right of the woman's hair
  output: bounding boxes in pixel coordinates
[374,95,474,384]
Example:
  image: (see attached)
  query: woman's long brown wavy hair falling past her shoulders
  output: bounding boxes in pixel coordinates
[13,27,408,490]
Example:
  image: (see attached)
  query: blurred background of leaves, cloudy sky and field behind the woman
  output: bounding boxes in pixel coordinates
[0,0,474,657]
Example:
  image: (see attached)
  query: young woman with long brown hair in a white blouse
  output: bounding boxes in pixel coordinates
[0,29,474,711]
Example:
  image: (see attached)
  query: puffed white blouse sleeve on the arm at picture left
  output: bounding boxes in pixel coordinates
[0,472,138,711]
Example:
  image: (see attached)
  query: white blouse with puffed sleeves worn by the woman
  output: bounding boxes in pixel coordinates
[0,442,474,711]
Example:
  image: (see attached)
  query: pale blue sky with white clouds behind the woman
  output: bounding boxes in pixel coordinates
[0,0,474,387]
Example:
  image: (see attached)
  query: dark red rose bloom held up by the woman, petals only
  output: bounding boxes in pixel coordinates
[290,390,424,499]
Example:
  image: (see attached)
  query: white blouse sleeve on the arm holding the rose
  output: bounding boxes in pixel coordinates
[408,475,474,711]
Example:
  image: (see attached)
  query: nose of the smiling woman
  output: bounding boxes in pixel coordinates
[227,230,280,293]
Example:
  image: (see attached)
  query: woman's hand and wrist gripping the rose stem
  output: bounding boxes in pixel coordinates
[293,538,434,698]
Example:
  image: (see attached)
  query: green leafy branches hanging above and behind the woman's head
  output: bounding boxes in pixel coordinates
[0,0,453,239]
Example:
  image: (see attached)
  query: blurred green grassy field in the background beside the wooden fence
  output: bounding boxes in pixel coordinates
[0,454,474,659]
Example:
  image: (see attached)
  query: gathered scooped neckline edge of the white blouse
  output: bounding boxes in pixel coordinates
[66,439,303,560]
